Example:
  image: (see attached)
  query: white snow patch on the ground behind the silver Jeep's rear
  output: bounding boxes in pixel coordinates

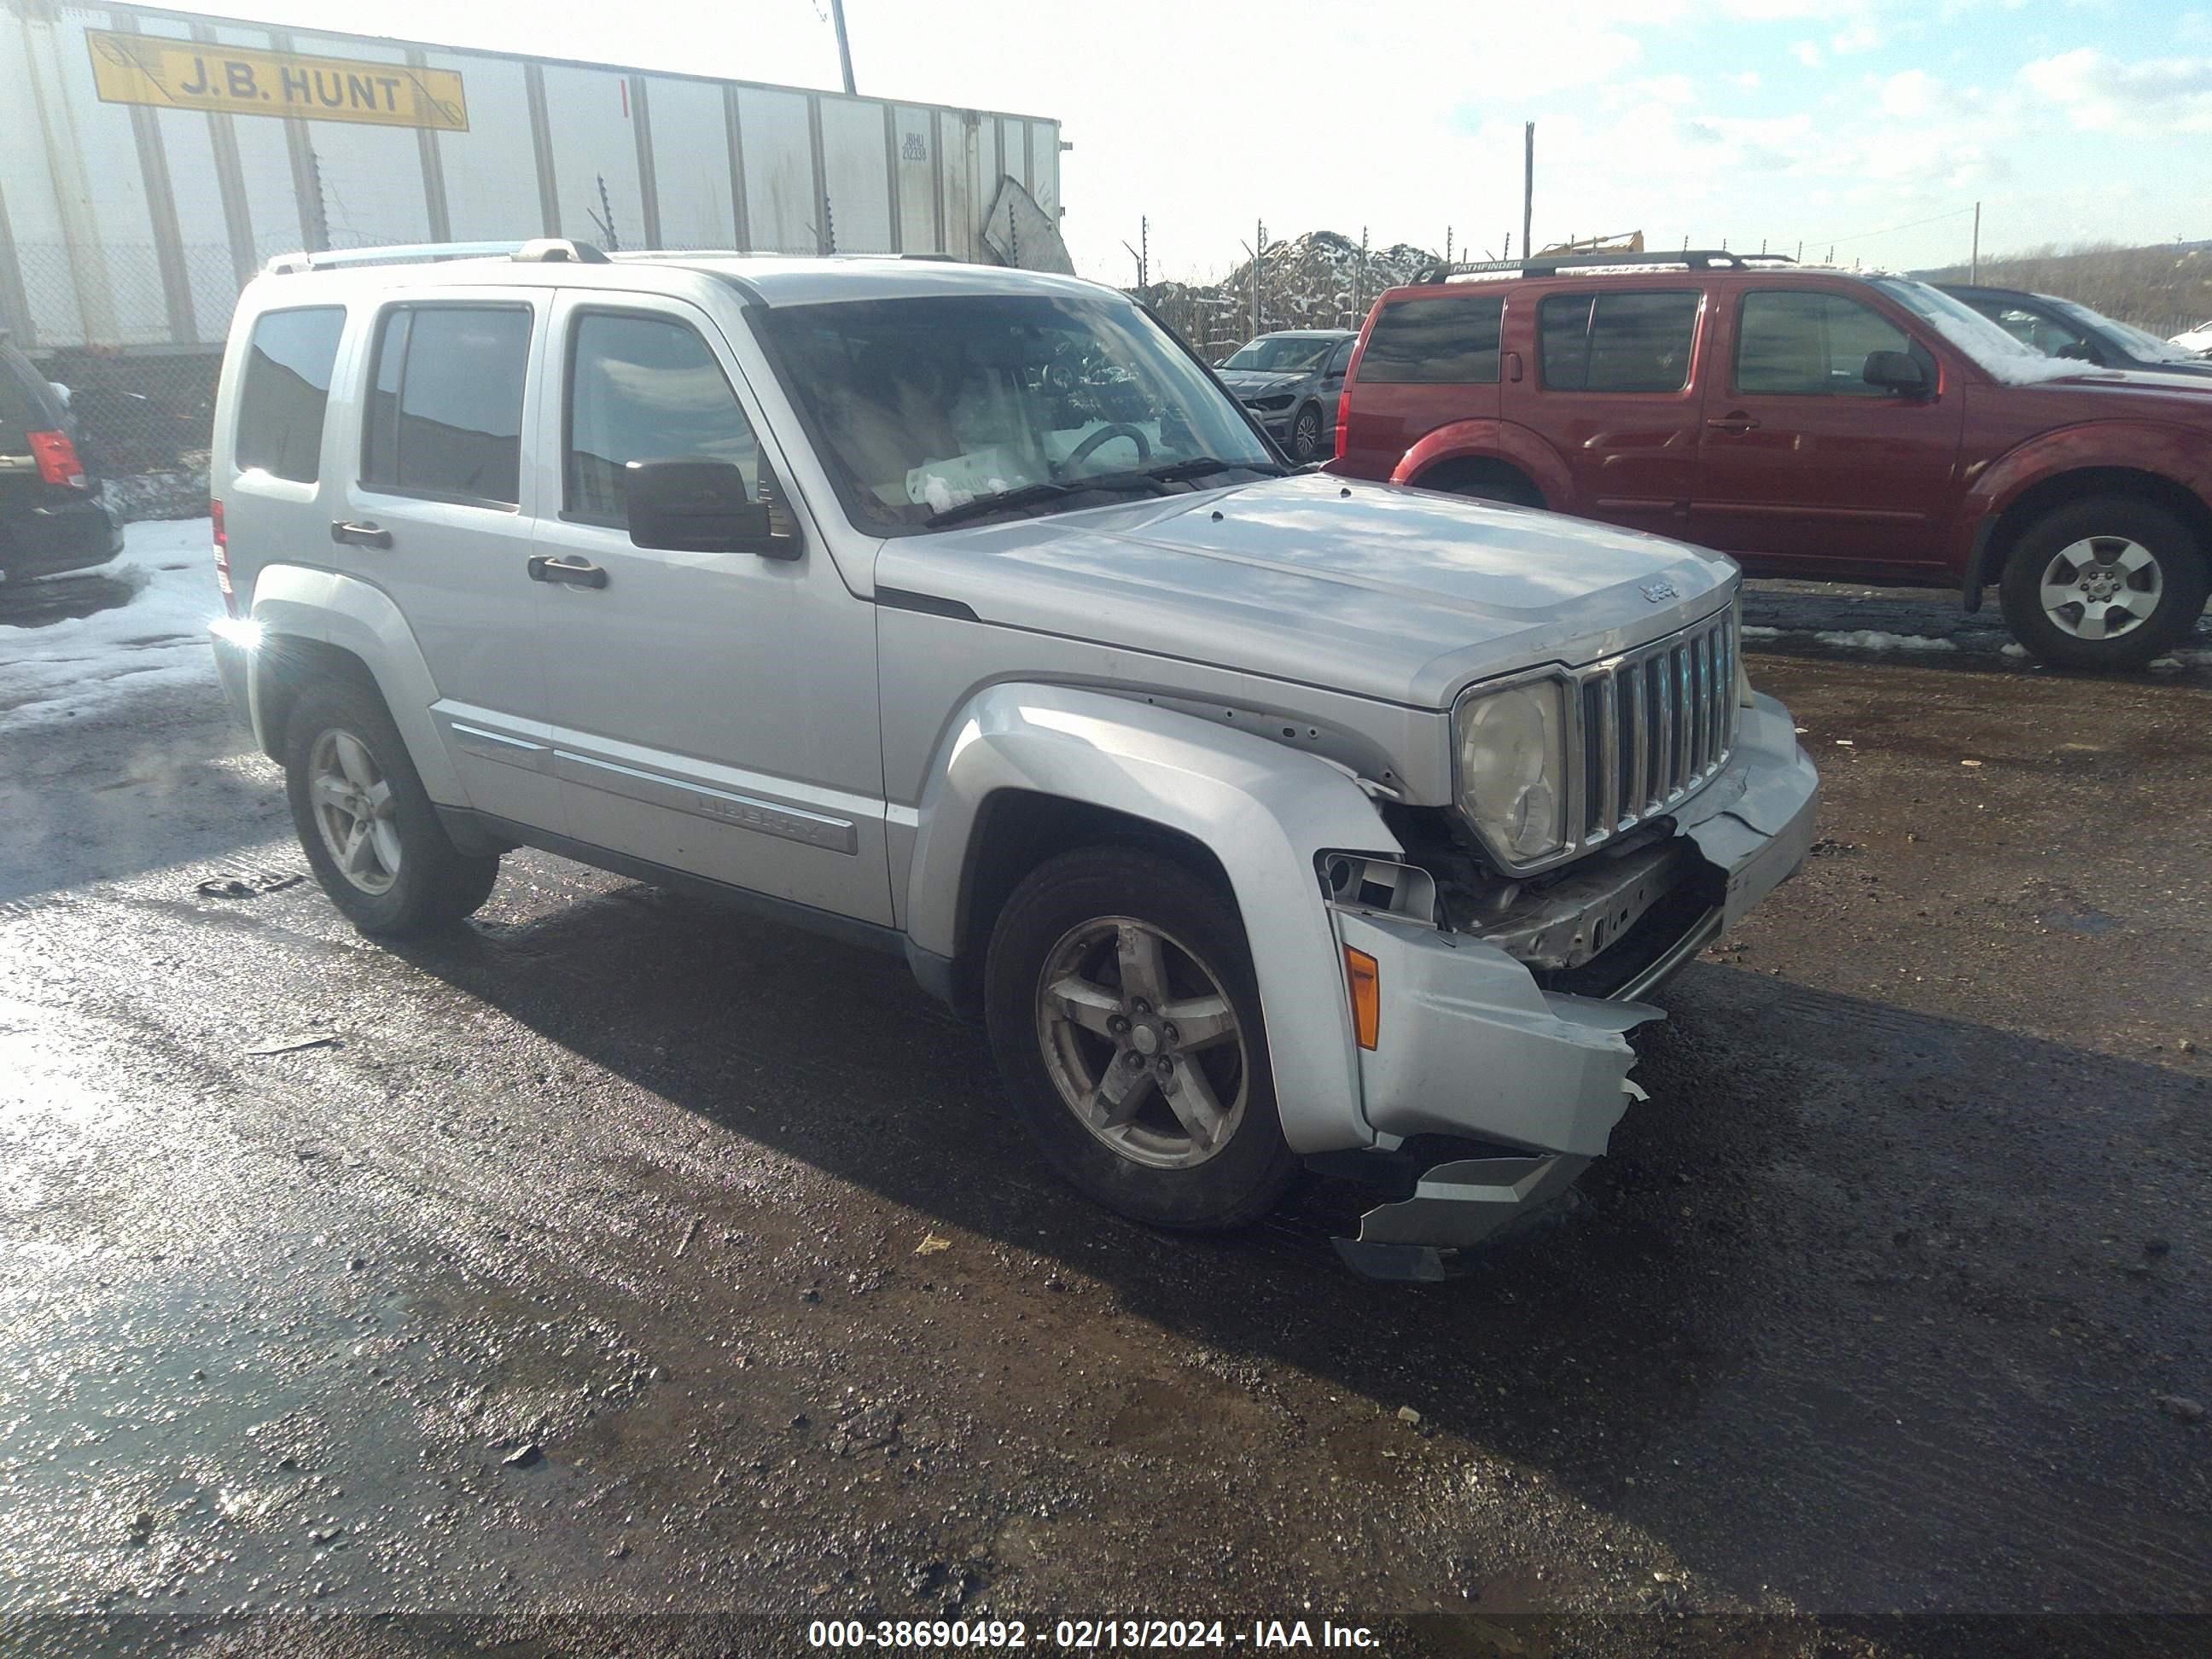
[0,518,224,728]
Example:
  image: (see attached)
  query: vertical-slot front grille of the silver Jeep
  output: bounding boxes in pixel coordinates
[1570,604,1738,847]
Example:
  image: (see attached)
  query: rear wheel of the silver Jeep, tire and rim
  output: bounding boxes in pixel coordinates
[283,679,500,938]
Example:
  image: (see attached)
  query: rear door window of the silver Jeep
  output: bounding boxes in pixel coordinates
[360,306,531,507]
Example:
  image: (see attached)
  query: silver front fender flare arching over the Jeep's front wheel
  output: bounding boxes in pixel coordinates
[905,684,1402,1152]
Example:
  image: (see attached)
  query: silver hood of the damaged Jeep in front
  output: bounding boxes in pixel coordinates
[876,474,1737,707]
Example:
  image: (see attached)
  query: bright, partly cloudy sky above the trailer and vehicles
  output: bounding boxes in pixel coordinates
[263,0,2212,281]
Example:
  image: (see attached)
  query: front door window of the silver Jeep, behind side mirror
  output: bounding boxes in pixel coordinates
[567,311,761,527]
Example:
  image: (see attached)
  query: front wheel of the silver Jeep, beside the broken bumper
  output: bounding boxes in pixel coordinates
[984,845,1299,1232]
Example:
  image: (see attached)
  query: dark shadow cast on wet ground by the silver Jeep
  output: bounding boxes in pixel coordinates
[389,887,2212,1610]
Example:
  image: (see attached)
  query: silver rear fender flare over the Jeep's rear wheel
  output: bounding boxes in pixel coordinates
[246,564,469,807]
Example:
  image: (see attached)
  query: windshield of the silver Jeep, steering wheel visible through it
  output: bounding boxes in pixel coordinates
[763,294,1281,535]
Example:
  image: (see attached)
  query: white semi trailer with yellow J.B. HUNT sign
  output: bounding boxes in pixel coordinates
[0,0,1066,354]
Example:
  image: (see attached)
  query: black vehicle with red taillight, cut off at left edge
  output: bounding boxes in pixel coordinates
[0,334,124,582]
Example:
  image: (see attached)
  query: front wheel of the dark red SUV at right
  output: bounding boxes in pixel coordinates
[1998,496,2212,668]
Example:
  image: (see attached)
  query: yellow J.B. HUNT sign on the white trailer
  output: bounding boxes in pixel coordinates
[84,29,469,133]
